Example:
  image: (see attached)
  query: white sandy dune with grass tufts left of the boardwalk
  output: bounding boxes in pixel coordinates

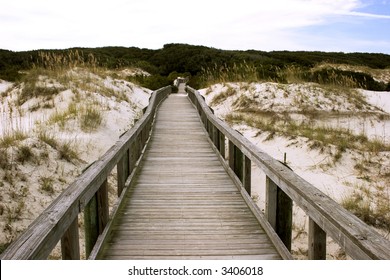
[0,69,151,256]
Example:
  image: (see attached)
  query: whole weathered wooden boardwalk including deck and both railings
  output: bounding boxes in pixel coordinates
[0,86,390,260]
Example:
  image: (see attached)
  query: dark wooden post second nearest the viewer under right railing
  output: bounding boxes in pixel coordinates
[265,176,293,251]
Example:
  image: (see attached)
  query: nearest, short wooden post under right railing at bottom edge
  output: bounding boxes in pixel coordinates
[309,217,326,260]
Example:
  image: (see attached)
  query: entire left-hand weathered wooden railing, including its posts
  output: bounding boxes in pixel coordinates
[1,86,171,260]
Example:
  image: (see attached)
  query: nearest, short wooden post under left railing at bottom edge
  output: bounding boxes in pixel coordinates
[61,217,80,260]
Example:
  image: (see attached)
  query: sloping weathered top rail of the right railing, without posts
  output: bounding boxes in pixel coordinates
[186,87,390,259]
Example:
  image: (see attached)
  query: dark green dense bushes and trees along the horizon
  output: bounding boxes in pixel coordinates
[0,44,390,90]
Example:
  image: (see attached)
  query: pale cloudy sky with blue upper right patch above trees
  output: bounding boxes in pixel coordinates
[0,0,390,54]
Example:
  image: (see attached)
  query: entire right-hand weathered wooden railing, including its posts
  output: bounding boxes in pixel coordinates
[186,87,390,260]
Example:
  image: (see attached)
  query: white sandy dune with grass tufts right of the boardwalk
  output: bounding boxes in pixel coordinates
[200,83,390,259]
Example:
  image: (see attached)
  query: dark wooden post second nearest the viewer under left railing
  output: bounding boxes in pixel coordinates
[84,179,109,258]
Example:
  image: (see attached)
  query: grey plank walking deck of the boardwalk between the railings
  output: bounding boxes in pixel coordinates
[102,86,281,259]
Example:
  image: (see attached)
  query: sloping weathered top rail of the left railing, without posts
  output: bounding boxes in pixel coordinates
[1,87,171,259]
